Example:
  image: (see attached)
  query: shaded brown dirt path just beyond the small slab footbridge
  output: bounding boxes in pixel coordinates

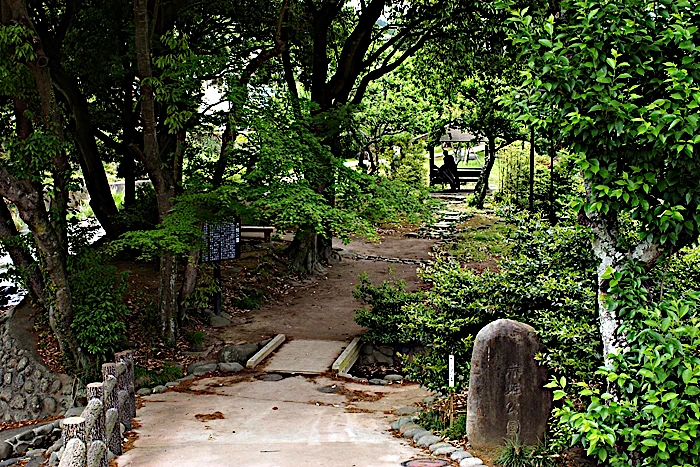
[208,236,435,347]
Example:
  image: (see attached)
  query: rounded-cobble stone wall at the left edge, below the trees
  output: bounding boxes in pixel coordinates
[0,308,73,422]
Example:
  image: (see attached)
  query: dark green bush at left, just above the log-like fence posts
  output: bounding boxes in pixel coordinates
[68,249,129,366]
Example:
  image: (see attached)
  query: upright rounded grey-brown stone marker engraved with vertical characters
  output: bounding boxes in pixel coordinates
[467,319,552,446]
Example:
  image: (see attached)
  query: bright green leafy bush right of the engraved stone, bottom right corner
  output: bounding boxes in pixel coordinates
[549,286,700,467]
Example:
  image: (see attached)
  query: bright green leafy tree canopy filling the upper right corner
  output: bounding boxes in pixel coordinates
[512,0,700,250]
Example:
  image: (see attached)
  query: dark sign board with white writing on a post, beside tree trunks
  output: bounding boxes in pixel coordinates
[202,218,241,315]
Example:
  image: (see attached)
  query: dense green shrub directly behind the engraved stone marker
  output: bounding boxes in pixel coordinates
[358,218,601,390]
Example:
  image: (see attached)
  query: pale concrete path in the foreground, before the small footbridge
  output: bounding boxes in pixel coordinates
[117,373,427,467]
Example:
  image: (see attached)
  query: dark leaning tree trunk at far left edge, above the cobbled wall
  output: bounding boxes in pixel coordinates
[0,200,48,309]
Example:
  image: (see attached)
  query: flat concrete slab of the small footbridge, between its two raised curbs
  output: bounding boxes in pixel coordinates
[264,339,348,374]
